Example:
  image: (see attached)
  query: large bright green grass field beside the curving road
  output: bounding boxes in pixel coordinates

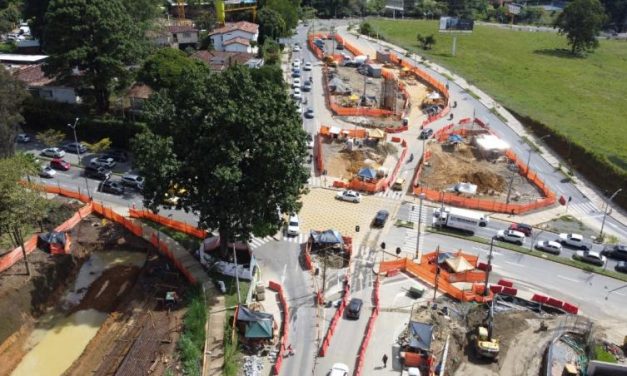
[369,20,627,173]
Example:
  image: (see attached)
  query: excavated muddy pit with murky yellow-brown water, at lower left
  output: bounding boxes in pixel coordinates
[0,215,189,376]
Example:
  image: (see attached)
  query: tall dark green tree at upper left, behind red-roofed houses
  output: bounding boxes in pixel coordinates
[43,0,142,112]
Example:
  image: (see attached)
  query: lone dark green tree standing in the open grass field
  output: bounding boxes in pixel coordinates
[555,0,605,55]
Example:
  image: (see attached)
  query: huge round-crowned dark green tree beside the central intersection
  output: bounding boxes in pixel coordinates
[133,65,308,258]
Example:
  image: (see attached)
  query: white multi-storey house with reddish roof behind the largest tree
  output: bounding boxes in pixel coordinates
[209,21,259,54]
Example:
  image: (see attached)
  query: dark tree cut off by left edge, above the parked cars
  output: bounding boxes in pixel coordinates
[0,67,28,158]
